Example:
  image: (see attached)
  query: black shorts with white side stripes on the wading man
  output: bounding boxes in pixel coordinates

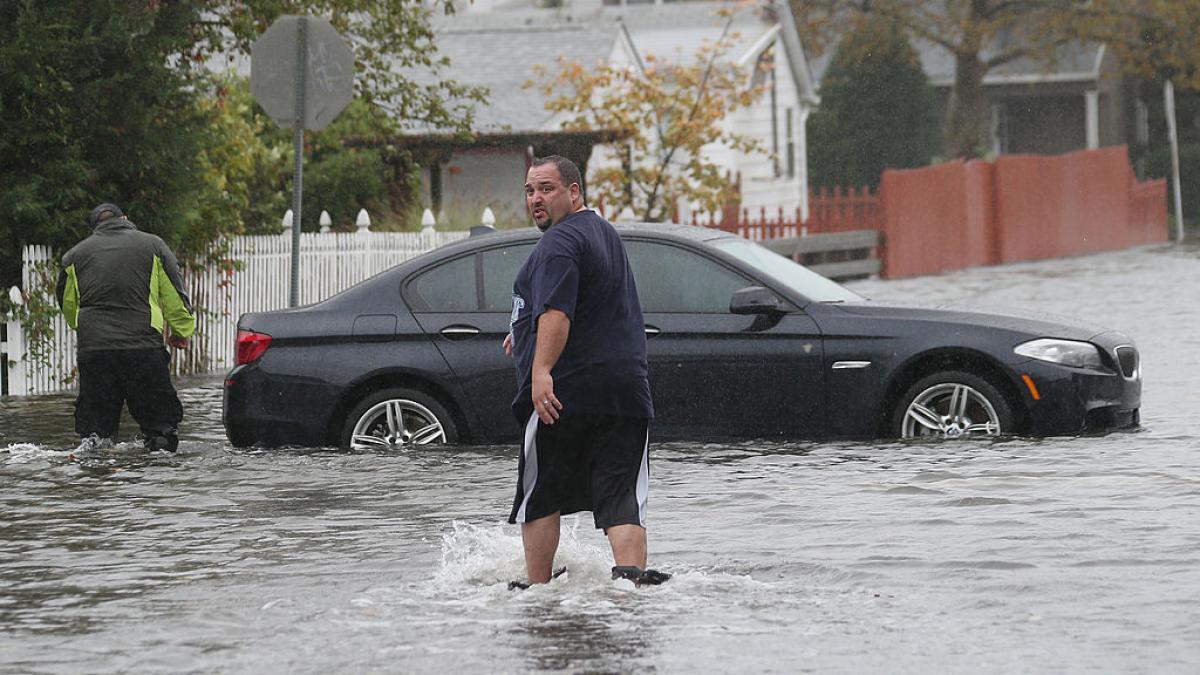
[509,413,649,530]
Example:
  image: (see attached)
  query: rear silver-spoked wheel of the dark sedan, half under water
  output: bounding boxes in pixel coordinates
[341,389,458,450]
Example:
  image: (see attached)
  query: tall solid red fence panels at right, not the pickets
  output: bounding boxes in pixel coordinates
[880,145,1166,277]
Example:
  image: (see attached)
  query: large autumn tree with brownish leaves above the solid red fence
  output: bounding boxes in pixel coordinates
[792,0,1200,157]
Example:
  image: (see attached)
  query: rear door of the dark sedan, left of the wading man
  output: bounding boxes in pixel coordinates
[404,243,534,441]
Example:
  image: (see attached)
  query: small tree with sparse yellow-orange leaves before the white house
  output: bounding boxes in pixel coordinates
[529,6,762,222]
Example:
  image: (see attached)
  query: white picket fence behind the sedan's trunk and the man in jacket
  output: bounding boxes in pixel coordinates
[0,228,467,395]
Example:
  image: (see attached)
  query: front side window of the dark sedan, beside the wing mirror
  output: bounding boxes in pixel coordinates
[625,241,756,313]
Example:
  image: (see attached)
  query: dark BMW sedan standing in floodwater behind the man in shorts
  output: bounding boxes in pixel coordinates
[223,225,1141,448]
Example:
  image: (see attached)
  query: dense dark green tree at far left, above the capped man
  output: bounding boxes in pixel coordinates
[0,0,204,286]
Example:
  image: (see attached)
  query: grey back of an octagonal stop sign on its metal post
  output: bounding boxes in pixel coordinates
[250,16,354,307]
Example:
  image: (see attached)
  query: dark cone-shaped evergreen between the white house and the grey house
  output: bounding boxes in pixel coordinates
[809,18,937,189]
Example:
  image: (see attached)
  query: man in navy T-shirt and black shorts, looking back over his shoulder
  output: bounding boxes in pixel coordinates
[504,156,670,589]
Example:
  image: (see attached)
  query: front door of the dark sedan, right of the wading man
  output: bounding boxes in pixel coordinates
[625,239,824,438]
